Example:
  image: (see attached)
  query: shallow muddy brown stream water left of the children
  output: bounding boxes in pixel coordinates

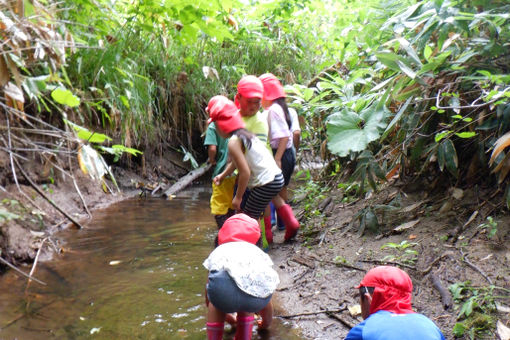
[0,188,301,339]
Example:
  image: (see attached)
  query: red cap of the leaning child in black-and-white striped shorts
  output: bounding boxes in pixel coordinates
[206,96,245,133]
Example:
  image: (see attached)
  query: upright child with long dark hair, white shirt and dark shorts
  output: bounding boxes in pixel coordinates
[259,73,296,239]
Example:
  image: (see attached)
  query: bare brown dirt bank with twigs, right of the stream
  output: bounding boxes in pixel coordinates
[270,179,510,339]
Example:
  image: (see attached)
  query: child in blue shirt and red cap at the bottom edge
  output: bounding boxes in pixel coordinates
[345,266,444,340]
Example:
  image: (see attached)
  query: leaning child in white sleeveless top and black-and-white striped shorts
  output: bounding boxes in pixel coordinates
[208,96,299,241]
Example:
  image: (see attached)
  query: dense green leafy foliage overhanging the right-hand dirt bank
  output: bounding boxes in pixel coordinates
[293,0,510,197]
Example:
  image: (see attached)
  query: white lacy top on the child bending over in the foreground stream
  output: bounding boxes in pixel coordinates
[203,242,280,298]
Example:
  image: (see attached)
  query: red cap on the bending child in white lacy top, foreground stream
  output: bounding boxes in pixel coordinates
[218,214,260,244]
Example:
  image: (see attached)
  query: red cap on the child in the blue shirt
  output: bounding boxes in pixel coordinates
[356,266,414,314]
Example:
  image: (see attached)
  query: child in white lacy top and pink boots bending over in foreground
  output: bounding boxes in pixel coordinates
[204,214,279,340]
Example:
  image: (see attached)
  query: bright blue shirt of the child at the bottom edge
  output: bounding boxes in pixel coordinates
[345,310,444,340]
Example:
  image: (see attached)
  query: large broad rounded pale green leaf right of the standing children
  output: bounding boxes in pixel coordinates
[327,103,388,157]
